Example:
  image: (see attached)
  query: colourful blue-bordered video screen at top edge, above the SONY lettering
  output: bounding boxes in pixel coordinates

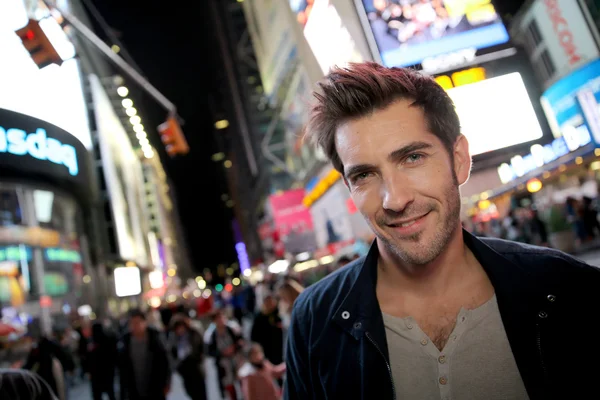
[362,0,509,67]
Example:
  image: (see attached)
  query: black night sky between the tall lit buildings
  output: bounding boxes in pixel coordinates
[89,0,236,271]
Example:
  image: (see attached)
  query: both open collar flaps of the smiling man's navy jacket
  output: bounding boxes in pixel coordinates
[333,230,548,346]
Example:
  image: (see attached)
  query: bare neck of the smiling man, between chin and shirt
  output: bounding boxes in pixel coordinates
[377,227,478,297]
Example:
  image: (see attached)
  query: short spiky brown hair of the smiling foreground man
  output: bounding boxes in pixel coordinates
[306,62,460,174]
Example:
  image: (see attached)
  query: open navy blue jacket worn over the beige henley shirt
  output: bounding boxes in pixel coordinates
[285,232,600,400]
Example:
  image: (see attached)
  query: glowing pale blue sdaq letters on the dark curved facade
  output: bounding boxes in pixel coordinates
[0,126,79,176]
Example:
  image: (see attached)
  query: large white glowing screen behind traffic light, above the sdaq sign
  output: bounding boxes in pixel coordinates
[0,0,92,149]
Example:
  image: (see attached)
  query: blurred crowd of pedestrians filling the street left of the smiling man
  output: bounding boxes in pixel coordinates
[0,278,303,400]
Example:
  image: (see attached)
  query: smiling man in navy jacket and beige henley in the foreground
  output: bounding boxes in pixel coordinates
[285,63,600,400]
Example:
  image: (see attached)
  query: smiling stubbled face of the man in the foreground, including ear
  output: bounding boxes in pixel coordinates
[335,100,471,265]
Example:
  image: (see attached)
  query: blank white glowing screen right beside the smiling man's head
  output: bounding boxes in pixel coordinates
[447,72,543,156]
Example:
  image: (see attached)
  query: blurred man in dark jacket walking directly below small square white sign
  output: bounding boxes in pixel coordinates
[119,310,171,400]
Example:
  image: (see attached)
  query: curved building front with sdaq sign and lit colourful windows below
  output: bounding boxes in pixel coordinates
[0,109,94,329]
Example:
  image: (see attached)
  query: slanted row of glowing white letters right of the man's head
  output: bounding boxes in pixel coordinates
[498,125,592,183]
